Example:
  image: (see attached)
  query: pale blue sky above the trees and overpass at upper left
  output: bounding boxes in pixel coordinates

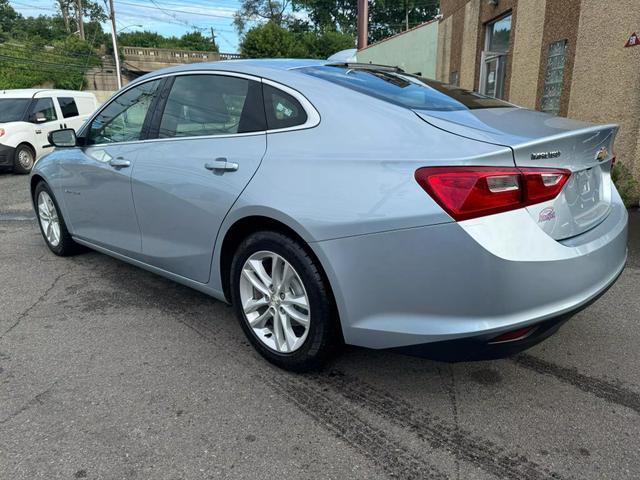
[9,0,245,53]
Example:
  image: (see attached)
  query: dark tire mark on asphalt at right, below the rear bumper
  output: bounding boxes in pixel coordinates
[512,353,640,413]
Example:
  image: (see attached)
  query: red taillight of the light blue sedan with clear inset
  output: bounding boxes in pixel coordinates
[415,167,571,221]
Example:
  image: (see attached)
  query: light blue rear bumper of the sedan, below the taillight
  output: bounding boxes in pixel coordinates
[314,188,628,349]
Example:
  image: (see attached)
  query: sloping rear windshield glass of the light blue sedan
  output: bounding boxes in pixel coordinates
[300,65,512,112]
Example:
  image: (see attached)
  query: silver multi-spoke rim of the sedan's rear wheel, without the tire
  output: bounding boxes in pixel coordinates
[240,251,311,353]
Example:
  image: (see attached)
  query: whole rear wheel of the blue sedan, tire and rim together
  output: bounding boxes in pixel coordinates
[231,231,342,372]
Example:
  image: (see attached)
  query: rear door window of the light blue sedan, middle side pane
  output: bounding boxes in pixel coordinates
[158,74,266,138]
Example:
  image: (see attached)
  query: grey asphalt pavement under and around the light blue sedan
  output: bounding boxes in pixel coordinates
[0,173,640,480]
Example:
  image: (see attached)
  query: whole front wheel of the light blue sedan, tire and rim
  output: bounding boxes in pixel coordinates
[33,181,85,257]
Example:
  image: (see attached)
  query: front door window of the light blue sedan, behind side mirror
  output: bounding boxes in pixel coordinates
[88,80,161,144]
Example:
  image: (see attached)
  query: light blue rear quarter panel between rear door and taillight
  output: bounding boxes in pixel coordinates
[211,74,513,289]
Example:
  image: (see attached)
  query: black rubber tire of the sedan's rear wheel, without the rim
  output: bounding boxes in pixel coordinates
[231,231,336,372]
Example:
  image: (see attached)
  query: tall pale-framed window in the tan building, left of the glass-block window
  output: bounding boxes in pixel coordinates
[480,14,511,98]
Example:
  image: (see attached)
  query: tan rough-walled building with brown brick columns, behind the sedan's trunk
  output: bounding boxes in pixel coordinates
[436,0,640,179]
